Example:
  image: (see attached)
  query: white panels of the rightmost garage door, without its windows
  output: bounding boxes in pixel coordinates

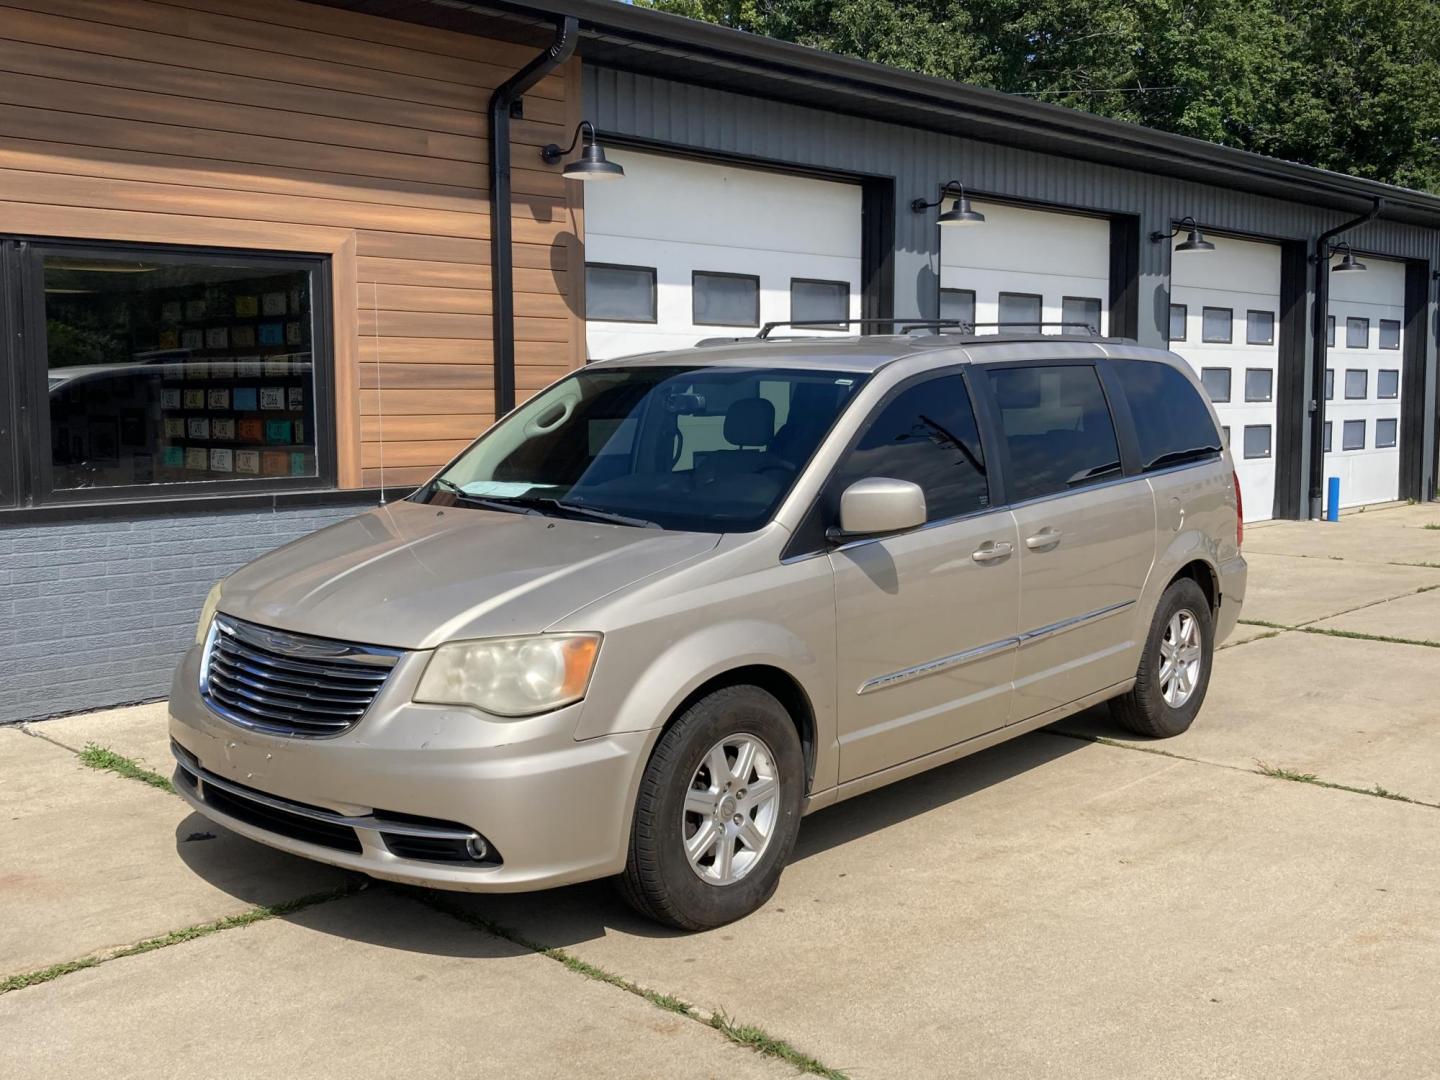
[1325,255,1405,507]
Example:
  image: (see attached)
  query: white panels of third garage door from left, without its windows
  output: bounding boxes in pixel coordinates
[1171,233,1280,521]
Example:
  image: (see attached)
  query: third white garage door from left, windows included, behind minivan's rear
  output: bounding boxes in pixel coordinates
[1169,233,1280,521]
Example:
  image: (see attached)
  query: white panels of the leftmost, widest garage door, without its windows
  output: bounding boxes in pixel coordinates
[585,150,861,360]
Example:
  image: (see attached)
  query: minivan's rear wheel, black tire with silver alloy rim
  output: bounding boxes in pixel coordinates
[1110,577,1215,739]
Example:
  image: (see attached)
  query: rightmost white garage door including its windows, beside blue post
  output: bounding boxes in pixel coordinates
[1325,255,1405,507]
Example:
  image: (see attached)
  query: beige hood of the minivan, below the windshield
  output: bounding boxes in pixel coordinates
[220,501,720,649]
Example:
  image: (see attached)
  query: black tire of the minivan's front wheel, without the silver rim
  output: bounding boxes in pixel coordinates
[632,687,805,929]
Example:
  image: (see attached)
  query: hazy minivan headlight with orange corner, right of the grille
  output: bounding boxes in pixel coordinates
[415,634,600,716]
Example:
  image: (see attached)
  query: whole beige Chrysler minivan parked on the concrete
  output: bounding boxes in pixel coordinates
[170,334,1246,929]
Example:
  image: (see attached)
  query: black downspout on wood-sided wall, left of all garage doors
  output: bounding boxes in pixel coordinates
[490,14,579,420]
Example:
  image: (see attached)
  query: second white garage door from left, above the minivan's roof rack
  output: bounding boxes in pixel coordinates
[930,203,1110,334]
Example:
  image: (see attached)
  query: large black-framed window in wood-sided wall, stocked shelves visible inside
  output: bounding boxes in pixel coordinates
[33,249,325,494]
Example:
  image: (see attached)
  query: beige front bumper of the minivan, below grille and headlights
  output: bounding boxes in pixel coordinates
[170,647,654,891]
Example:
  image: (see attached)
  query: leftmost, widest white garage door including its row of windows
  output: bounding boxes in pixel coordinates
[585,150,861,360]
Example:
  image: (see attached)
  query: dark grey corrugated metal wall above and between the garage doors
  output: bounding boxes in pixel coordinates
[583,65,1440,506]
